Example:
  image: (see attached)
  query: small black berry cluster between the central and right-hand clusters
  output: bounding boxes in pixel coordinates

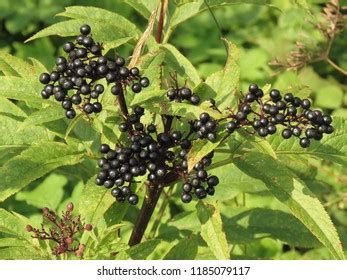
[193,113,218,142]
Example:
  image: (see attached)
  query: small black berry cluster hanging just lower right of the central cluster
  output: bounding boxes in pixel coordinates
[179,149,219,203]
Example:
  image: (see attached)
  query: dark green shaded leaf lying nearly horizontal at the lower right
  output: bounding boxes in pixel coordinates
[223,208,320,248]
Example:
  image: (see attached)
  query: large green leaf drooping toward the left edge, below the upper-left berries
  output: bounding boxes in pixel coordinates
[0,142,83,201]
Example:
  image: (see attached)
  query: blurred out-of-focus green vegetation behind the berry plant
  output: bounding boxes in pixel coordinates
[0,0,347,258]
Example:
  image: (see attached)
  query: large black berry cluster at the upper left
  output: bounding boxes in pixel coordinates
[39,24,149,119]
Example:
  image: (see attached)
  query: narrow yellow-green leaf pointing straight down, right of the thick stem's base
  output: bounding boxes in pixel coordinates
[196,202,229,260]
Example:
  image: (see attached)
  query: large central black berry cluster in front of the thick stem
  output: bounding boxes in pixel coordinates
[96,107,181,205]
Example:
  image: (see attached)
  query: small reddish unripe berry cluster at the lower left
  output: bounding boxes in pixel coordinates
[26,203,93,257]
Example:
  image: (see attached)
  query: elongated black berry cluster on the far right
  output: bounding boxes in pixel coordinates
[226,84,334,148]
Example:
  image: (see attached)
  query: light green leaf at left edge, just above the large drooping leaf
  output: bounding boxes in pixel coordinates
[0,115,53,149]
